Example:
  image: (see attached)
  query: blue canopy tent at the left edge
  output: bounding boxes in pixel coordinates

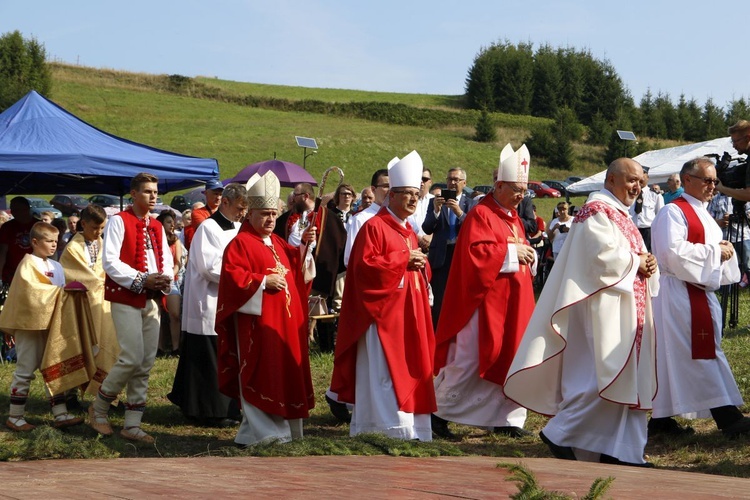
[0,90,219,198]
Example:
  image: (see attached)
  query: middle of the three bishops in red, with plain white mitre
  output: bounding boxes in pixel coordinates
[331,151,436,441]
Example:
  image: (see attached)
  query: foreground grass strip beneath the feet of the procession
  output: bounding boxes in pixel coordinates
[0,292,750,477]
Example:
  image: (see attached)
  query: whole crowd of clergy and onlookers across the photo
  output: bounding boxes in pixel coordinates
[0,120,750,467]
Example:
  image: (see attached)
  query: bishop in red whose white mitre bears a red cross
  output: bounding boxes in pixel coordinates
[432,144,536,437]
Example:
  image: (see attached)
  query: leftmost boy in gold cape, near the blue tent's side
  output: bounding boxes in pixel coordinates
[0,222,83,432]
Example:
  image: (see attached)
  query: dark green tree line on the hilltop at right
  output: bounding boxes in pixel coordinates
[465,40,750,169]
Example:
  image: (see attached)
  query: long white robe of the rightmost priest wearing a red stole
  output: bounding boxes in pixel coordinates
[651,193,743,418]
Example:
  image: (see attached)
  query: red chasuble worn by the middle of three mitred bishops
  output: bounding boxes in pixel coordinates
[331,208,437,413]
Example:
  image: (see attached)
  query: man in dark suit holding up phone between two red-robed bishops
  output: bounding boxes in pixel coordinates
[422,167,472,326]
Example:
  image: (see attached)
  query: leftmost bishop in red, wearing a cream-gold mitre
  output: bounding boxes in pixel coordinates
[216,172,315,445]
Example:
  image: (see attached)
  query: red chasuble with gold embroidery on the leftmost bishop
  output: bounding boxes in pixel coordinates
[216,221,315,419]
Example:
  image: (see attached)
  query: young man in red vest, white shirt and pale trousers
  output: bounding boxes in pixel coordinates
[89,172,173,443]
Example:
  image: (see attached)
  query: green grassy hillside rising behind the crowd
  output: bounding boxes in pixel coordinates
[51,64,603,199]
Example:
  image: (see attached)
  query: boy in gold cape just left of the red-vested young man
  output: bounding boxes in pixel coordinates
[60,205,120,396]
